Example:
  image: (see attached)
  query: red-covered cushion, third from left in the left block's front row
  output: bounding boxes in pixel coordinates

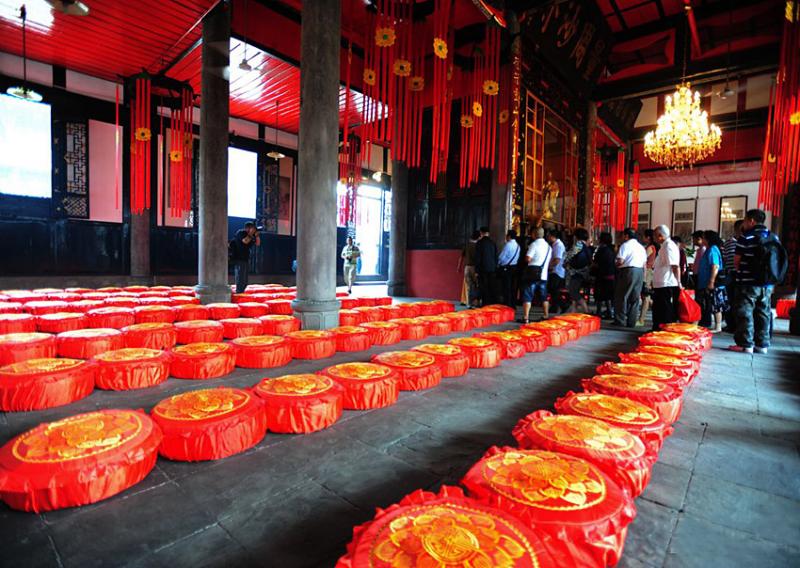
[253,374,343,434]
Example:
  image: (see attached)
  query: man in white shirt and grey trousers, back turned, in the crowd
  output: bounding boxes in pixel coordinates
[614,227,647,328]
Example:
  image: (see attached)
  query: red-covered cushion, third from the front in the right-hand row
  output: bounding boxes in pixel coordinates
[512,410,658,497]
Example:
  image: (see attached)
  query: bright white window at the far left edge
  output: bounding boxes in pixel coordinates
[0,95,53,198]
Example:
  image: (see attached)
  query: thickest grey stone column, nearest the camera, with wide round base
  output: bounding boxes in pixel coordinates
[292,0,341,329]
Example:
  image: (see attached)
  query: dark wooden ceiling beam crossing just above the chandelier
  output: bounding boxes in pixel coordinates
[592,42,778,101]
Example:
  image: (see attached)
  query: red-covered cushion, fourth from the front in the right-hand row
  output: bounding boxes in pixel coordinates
[555,391,673,453]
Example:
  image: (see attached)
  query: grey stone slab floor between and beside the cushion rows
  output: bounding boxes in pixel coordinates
[0,310,800,568]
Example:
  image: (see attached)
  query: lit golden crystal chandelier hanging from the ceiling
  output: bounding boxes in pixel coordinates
[644,83,722,170]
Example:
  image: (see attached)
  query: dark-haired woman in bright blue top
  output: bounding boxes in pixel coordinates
[697,231,728,333]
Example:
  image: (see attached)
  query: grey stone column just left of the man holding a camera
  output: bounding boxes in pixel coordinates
[196,3,231,304]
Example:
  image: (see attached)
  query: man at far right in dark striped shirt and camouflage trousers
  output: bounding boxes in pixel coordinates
[728,209,772,354]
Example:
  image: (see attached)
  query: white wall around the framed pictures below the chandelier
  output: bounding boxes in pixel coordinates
[639,181,772,231]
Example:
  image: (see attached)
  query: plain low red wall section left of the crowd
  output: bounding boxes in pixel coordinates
[406,250,464,300]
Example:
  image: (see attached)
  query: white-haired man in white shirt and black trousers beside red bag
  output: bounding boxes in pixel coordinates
[653,225,681,331]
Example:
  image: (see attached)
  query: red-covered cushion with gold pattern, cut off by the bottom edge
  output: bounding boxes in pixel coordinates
[336,485,563,568]
